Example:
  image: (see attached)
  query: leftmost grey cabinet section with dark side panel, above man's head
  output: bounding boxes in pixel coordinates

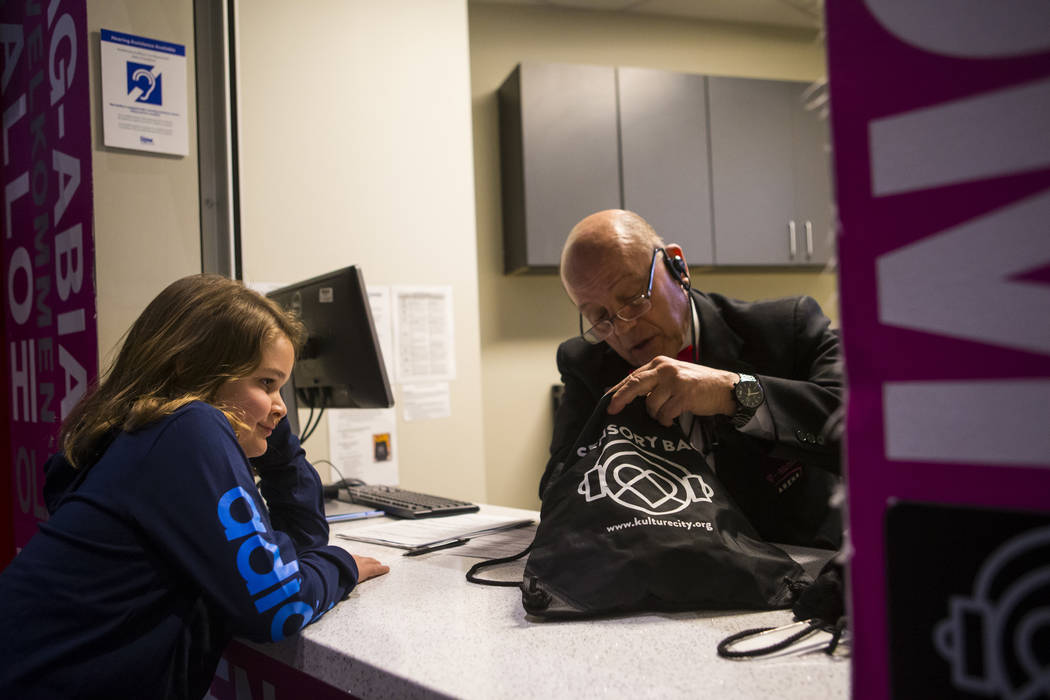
[499,63,622,273]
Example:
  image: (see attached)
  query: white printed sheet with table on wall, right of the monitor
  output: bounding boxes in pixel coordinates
[393,285,456,382]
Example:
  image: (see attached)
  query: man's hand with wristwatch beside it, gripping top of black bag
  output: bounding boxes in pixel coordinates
[609,356,739,426]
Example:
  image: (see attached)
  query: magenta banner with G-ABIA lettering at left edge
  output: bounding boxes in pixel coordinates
[0,0,98,548]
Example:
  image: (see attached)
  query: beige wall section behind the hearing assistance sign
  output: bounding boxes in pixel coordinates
[87,0,201,369]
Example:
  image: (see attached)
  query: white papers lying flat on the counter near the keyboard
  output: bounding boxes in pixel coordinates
[338,513,533,549]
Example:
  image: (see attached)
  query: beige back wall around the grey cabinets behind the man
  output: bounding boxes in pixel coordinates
[469,2,837,507]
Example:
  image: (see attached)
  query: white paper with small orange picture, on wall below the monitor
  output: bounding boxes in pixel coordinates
[324,408,398,484]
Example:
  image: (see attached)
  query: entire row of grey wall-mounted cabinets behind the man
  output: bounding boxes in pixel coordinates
[499,63,832,272]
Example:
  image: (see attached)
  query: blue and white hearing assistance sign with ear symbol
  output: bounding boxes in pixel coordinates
[101,29,188,155]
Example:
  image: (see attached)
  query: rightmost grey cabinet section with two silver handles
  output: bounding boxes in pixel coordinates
[708,77,832,266]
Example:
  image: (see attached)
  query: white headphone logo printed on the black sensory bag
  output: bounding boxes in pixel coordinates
[576,439,714,515]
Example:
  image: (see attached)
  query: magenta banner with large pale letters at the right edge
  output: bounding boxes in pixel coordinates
[826,0,1050,698]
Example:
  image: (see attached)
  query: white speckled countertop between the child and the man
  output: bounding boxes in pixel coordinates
[245,506,849,700]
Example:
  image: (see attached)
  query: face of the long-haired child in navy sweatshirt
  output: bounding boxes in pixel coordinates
[214,335,295,457]
